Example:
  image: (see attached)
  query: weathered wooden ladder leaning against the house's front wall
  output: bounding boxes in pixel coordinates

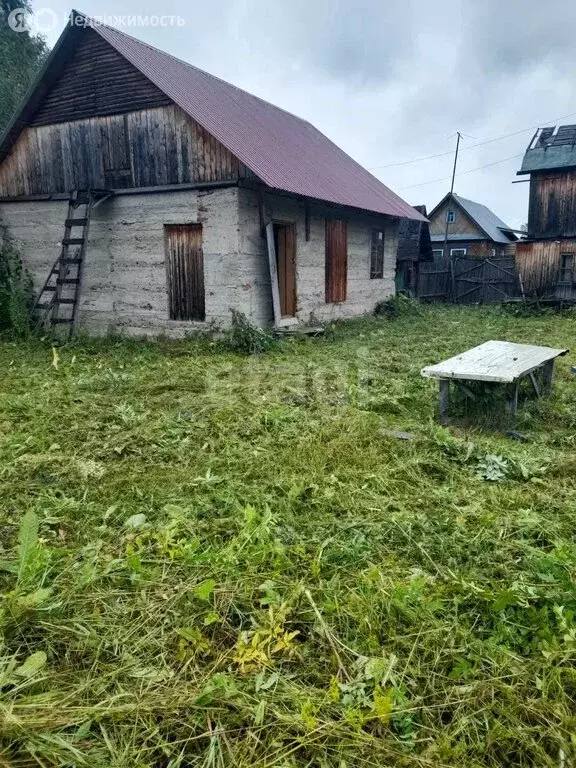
[34,190,110,338]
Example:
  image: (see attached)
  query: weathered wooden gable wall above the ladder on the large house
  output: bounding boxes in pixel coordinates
[0,28,249,198]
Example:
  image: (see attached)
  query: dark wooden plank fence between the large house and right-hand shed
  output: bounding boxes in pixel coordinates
[418,256,520,304]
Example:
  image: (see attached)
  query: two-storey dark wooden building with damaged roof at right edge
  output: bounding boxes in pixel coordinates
[516,125,576,299]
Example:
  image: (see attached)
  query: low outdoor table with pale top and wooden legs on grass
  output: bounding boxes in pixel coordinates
[422,341,569,422]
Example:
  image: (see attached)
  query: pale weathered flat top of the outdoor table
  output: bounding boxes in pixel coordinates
[422,341,570,384]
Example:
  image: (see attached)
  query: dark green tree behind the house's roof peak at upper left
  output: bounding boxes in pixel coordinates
[0,0,48,134]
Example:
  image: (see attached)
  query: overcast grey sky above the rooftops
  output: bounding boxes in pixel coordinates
[34,0,576,227]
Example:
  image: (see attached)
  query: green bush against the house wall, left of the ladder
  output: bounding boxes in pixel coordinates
[0,229,34,336]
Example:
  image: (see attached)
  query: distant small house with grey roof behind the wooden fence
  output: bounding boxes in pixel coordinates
[428,193,518,259]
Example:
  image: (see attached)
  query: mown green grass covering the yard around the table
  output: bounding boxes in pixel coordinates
[0,307,576,768]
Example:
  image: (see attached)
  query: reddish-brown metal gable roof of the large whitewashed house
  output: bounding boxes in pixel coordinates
[0,11,424,220]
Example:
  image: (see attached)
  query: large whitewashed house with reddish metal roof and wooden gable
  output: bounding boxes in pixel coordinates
[0,11,424,336]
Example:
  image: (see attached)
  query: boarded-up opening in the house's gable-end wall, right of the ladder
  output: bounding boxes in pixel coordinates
[164,224,206,320]
